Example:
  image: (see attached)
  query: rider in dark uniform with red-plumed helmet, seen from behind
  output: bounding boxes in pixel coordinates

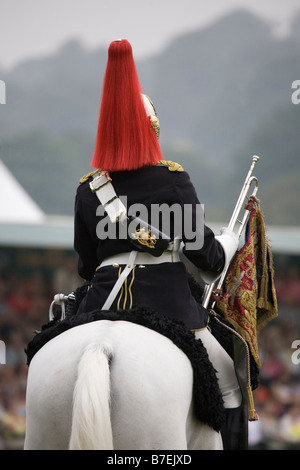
[74,40,246,449]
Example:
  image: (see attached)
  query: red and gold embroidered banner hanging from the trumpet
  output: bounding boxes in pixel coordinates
[217,203,278,368]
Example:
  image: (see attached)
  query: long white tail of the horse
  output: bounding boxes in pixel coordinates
[69,344,113,450]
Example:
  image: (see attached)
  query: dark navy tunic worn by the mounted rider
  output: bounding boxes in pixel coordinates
[74,165,224,329]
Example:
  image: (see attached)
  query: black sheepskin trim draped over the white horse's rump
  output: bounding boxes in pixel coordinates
[25,308,225,431]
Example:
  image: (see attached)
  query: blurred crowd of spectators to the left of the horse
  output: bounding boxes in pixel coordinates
[0,252,82,450]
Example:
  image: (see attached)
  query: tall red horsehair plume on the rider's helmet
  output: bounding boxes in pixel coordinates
[91,39,162,171]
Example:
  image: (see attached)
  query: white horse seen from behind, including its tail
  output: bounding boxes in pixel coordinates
[25,320,222,450]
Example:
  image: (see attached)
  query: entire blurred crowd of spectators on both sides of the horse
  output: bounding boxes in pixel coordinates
[0,252,300,450]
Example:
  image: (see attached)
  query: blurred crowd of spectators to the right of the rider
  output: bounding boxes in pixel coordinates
[249,264,300,450]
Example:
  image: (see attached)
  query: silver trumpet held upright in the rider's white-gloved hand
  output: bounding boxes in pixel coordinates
[202,155,259,309]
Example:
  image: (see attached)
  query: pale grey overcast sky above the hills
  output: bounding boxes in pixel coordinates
[0,0,300,68]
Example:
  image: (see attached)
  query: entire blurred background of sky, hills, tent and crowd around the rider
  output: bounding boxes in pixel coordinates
[0,0,300,449]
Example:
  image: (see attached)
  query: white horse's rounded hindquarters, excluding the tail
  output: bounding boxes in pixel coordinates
[25,320,193,450]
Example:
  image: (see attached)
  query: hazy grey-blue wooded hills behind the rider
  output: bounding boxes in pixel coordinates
[0,12,300,225]
